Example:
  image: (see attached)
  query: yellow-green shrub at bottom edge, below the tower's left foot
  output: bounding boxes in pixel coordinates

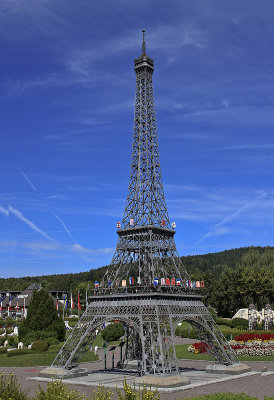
[34,380,88,400]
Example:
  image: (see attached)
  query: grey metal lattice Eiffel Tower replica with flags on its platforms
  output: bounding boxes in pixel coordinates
[47,31,248,377]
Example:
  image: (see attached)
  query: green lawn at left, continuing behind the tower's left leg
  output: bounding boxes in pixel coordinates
[0,345,98,367]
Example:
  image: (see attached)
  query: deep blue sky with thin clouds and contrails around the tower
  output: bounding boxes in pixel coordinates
[0,0,274,277]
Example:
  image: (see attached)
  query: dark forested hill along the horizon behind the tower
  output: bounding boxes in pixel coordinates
[0,246,274,291]
